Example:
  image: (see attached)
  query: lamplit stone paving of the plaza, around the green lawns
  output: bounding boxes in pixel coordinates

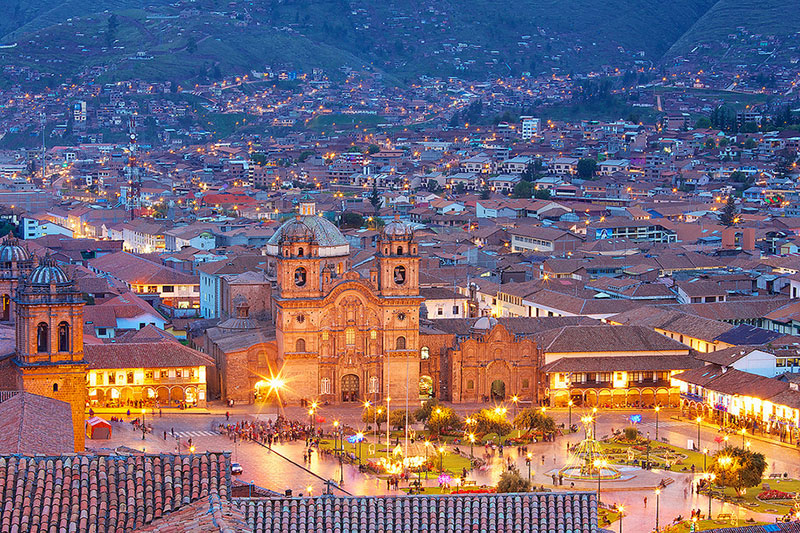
[87,405,800,533]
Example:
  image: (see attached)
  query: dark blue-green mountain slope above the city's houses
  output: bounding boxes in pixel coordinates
[0,0,800,81]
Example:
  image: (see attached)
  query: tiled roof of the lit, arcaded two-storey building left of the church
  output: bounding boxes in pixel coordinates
[83,340,214,369]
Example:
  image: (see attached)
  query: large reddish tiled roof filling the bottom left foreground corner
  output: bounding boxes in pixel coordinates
[0,453,230,532]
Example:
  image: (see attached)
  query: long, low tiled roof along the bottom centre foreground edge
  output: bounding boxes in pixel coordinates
[241,492,597,533]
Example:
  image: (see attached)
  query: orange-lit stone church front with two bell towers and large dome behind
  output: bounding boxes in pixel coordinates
[266,203,422,403]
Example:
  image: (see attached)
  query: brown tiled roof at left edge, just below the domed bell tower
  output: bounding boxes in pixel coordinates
[0,392,75,454]
